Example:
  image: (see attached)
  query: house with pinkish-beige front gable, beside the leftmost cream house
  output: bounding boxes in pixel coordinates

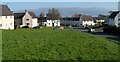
[14,10,39,28]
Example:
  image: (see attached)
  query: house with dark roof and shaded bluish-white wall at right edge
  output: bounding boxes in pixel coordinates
[108,11,120,27]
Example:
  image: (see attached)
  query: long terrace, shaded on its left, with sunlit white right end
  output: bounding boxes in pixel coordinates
[61,15,95,27]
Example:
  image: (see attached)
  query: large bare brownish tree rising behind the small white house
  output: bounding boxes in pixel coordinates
[47,8,60,20]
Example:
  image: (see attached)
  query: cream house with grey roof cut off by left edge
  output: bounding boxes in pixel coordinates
[0,5,14,29]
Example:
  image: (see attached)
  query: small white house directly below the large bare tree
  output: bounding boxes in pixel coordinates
[39,16,60,27]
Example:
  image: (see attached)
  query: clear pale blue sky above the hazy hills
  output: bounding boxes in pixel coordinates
[0,2,118,11]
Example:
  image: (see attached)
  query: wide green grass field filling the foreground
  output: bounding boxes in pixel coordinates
[2,28,119,60]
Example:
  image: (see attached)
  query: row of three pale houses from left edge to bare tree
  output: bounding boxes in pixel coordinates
[0,5,60,29]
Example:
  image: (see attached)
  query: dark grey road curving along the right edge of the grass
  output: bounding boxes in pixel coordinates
[73,27,120,42]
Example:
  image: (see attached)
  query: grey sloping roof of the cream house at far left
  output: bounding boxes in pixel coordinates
[0,5,13,16]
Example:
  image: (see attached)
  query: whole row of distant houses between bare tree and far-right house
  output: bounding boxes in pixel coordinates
[61,14,107,27]
